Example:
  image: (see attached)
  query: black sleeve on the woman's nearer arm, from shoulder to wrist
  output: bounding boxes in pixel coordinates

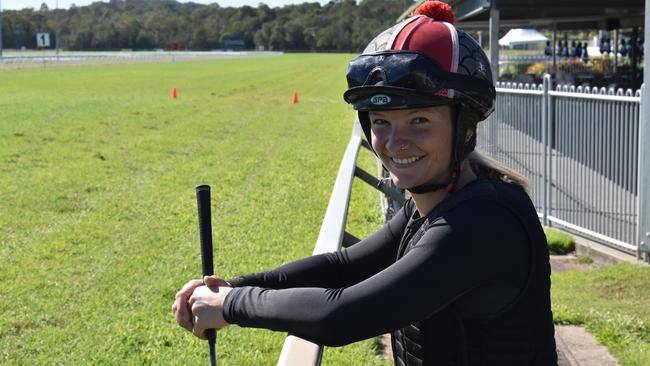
[224,200,527,346]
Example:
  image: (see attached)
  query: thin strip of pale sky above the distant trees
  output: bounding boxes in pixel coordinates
[0,0,329,10]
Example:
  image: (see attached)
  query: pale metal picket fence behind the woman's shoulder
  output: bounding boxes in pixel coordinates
[478,79,641,252]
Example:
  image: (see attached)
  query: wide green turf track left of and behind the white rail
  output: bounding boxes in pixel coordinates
[0,55,387,365]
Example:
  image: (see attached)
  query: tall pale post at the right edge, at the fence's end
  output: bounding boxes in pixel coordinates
[637,0,650,262]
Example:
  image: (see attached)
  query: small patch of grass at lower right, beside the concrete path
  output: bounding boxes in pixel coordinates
[551,264,650,366]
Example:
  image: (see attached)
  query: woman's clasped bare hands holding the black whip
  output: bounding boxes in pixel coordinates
[172,276,232,339]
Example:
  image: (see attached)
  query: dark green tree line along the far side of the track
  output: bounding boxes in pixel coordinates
[2,0,404,51]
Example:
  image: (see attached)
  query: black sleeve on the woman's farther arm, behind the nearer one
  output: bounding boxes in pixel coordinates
[228,206,410,289]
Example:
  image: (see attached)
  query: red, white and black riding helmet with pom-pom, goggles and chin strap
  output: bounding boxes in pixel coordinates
[343,1,496,193]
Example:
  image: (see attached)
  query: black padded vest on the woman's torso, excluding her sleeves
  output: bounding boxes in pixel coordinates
[391,183,557,366]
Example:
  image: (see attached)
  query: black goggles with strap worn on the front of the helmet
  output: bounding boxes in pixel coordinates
[343,51,494,111]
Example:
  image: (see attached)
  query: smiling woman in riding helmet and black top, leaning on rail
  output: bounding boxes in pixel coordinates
[173,1,557,366]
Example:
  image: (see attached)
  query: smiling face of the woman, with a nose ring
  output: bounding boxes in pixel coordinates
[370,106,453,188]
